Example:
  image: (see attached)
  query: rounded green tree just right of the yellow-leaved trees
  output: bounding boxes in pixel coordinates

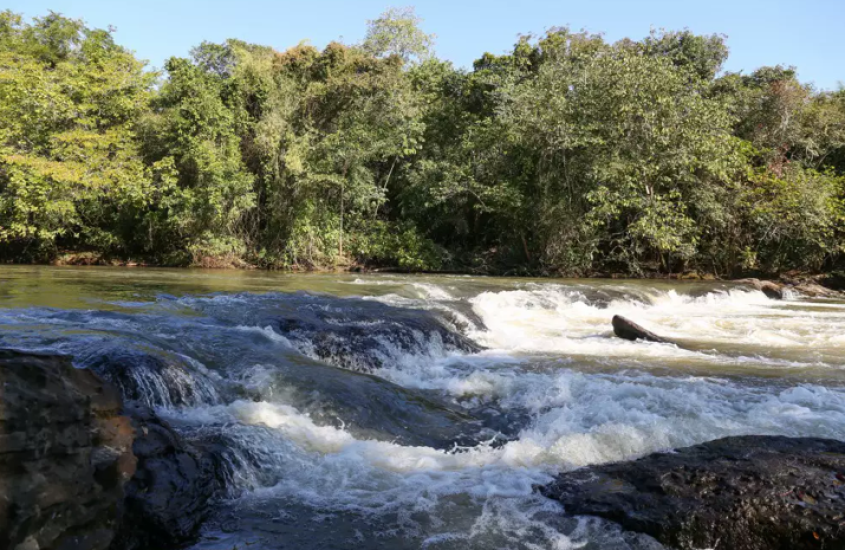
[138,54,255,264]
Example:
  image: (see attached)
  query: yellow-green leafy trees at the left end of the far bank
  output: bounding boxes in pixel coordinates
[0,8,154,258]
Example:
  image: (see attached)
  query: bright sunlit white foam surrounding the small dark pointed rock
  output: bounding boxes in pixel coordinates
[458,285,845,368]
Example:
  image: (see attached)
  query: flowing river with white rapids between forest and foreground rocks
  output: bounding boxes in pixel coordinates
[0,267,845,550]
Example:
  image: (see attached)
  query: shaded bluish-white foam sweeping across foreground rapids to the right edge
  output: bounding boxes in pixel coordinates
[172,362,845,548]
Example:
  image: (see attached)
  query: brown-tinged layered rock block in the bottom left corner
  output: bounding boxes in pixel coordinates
[0,350,135,550]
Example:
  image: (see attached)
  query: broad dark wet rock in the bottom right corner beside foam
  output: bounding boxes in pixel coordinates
[540,436,845,550]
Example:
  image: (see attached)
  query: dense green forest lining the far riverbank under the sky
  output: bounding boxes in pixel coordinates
[0,9,845,277]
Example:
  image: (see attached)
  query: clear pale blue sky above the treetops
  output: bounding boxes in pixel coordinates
[5,0,845,89]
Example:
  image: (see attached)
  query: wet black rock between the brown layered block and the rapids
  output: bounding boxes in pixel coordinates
[114,403,220,550]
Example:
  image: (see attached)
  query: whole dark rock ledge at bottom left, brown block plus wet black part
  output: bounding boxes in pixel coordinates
[0,349,219,550]
